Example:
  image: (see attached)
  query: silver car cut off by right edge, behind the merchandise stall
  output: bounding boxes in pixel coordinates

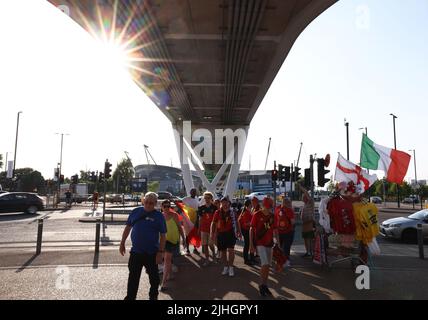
[380,209,428,242]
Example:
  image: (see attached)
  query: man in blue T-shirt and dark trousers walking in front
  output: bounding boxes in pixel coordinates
[119,192,166,300]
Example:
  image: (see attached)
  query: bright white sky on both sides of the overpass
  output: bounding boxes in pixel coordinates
[0,0,428,179]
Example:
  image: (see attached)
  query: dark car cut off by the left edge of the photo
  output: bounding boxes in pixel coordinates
[0,192,45,214]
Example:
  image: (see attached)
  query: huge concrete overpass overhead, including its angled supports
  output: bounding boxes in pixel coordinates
[49,0,337,195]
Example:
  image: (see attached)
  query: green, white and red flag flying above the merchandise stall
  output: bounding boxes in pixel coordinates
[361,134,411,184]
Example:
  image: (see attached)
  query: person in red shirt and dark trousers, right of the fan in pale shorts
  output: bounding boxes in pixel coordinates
[275,197,295,267]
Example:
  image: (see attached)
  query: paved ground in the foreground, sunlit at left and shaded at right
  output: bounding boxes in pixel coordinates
[0,248,428,300]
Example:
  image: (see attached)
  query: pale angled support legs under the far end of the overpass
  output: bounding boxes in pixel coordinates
[173,121,249,198]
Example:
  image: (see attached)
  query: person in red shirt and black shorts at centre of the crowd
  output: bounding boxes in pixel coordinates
[211,197,241,277]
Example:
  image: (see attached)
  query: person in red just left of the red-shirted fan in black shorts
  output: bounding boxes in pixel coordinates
[198,192,217,267]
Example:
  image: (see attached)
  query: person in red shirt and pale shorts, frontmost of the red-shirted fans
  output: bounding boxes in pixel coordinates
[250,198,278,296]
